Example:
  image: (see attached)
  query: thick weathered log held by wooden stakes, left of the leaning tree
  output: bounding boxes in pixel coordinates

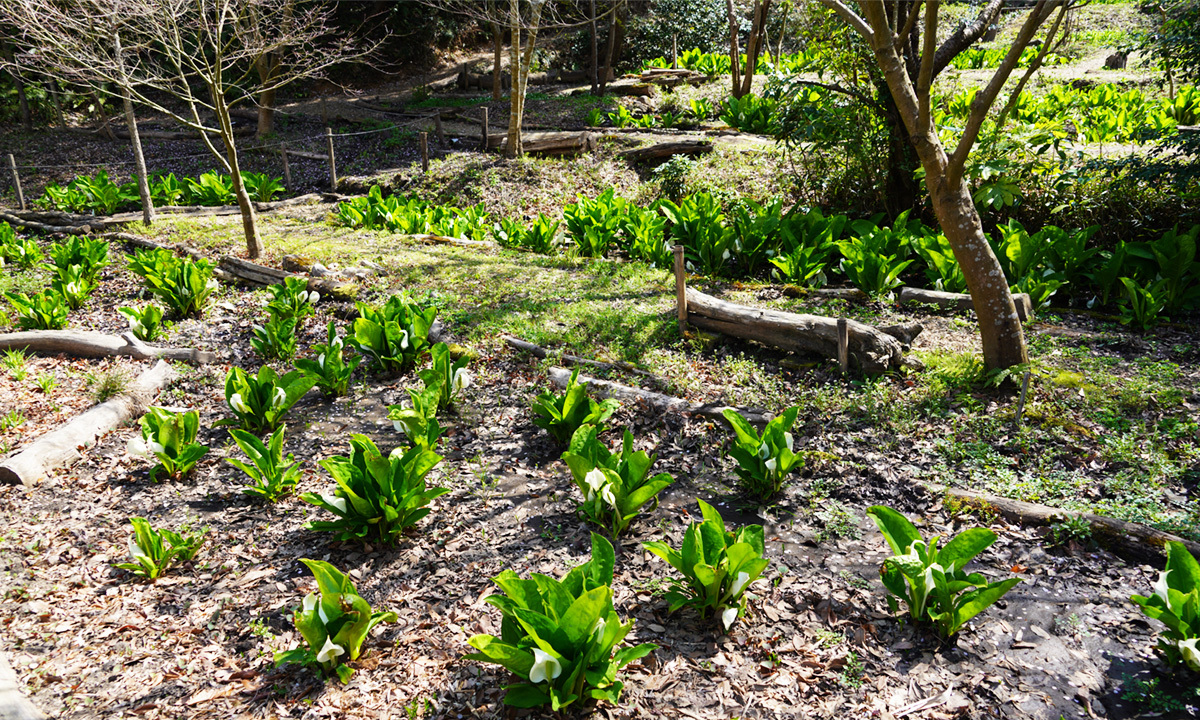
[685,288,904,373]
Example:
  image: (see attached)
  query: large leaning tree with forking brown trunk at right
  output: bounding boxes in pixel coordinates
[821,0,1073,368]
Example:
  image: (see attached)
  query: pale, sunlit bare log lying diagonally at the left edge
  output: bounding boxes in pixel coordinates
[0,360,174,487]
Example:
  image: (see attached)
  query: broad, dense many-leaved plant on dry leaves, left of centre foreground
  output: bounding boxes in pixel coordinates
[300,434,450,545]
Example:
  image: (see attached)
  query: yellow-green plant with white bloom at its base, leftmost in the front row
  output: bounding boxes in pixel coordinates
[275,558,396,683]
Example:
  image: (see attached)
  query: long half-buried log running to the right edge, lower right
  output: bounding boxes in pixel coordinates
[926,482,1200,560]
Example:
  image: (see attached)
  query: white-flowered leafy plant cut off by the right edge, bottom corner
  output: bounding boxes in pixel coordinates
[1130,541,1200,672]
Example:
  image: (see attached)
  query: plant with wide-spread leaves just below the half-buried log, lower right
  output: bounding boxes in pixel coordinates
[866,505,1021,637]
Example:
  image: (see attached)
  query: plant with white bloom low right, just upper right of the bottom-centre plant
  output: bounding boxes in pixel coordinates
[642,500,769,631]
